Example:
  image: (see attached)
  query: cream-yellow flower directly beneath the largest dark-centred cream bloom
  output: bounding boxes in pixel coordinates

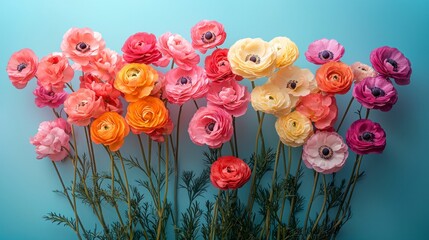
[250,84,296,117]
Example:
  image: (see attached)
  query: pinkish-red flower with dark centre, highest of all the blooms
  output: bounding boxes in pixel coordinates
[191,20,226,53]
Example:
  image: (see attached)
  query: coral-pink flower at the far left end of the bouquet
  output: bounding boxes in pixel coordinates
[6,48,39,89]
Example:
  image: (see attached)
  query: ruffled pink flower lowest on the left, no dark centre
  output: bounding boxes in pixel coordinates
[30,118,71,161]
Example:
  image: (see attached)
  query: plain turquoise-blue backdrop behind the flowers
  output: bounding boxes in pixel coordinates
[0,0,429,239]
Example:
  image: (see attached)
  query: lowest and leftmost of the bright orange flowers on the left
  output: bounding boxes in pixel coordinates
[90,112,130,151]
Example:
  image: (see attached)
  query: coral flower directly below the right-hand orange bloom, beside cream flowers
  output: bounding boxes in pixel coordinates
[296,93,338,130]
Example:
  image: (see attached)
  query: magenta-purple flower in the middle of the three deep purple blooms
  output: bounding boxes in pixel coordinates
[353,76,398,112]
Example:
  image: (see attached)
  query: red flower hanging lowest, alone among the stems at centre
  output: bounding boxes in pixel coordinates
[210,156,252,190]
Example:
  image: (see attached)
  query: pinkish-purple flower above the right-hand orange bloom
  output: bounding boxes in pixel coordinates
[305,38,345,65]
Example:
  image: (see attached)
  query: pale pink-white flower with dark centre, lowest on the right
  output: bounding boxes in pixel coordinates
[302,131,349,174]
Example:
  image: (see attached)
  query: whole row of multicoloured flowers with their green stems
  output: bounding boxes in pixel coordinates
[7,20,412,239]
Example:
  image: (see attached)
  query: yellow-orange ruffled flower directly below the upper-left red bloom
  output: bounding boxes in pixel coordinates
[114,63,158,102]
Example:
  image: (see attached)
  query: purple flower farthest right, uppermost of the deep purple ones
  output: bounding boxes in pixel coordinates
[370,46,412,85]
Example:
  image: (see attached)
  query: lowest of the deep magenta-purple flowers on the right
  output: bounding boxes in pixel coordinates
[346,119,386,154]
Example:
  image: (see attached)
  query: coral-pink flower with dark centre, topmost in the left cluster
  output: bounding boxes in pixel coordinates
[61,28,106,66]
